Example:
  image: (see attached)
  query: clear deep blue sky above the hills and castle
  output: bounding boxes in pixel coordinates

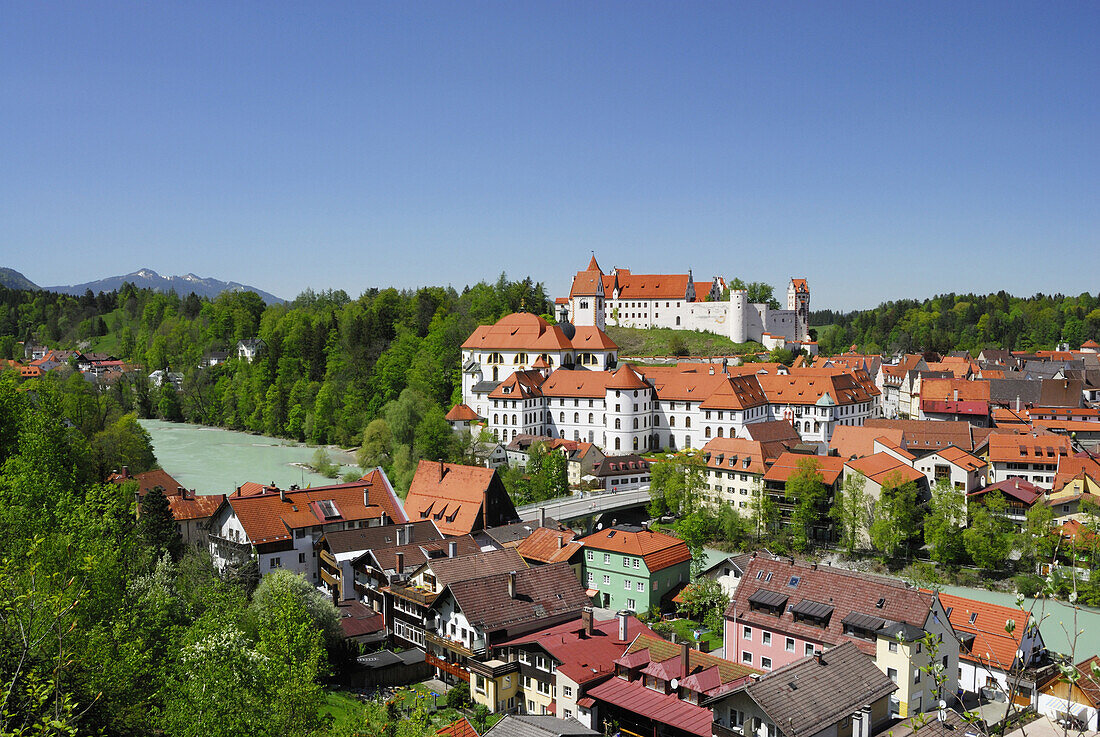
[0,0,1100,309]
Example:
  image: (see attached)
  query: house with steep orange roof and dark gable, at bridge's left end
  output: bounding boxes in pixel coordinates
[405,461,519,535]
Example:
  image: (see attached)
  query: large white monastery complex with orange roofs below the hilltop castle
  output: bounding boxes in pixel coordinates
[462,312,879,454]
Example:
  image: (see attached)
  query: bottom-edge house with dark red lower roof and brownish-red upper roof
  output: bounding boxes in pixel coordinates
[579,635,760,737]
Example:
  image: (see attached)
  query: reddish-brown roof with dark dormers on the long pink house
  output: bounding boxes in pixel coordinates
[726,556,935,656]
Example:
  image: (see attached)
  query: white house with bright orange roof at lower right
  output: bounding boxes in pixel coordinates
[939,593,1051,707]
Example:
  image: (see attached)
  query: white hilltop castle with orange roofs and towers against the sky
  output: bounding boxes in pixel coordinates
[562,256,816,352]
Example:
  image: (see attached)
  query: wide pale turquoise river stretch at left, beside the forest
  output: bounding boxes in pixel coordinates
[140,420,358,494]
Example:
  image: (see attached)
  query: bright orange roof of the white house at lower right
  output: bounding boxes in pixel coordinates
[939,593,1029,671]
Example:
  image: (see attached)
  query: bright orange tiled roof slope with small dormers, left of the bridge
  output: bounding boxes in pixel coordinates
[405,461,496,535]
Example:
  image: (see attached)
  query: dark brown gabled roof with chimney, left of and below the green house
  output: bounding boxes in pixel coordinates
[442,563,590,633]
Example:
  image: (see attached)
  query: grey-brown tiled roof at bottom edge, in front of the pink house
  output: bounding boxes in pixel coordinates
[745,642,898,737]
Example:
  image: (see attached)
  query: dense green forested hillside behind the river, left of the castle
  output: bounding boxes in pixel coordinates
[0,274,551,481]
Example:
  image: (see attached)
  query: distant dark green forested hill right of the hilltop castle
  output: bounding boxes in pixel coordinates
[810,292,1100,354]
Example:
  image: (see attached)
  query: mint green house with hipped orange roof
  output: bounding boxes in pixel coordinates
[580,525,691,612]
